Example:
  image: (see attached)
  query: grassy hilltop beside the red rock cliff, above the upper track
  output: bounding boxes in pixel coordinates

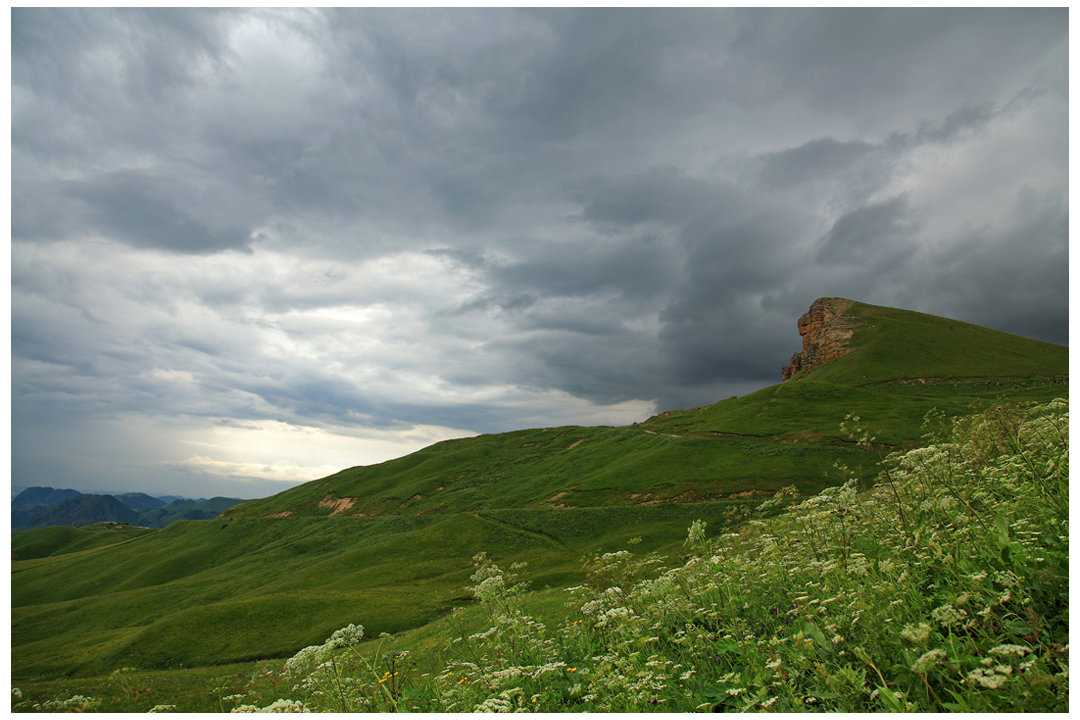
[643,295,1068,445]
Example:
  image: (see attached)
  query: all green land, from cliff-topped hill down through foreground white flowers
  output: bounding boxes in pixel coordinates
[12,303,1068,711]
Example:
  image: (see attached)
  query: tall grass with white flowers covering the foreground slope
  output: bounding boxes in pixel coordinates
[16,400,1069,712]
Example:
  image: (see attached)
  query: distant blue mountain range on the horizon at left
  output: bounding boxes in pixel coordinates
[11,487,244,531]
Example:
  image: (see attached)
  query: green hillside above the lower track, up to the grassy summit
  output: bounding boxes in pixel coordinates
[227,298,1068,524]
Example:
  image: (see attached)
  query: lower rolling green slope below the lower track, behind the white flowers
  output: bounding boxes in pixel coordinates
[12,501,739,679]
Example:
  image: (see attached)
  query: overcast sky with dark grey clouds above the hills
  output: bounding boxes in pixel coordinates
[11,8,1068,498]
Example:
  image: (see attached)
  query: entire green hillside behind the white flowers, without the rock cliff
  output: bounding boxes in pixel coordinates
[12,301,1067,703]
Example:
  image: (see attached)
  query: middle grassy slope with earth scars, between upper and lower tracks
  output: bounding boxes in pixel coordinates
[226,427,876,517]
